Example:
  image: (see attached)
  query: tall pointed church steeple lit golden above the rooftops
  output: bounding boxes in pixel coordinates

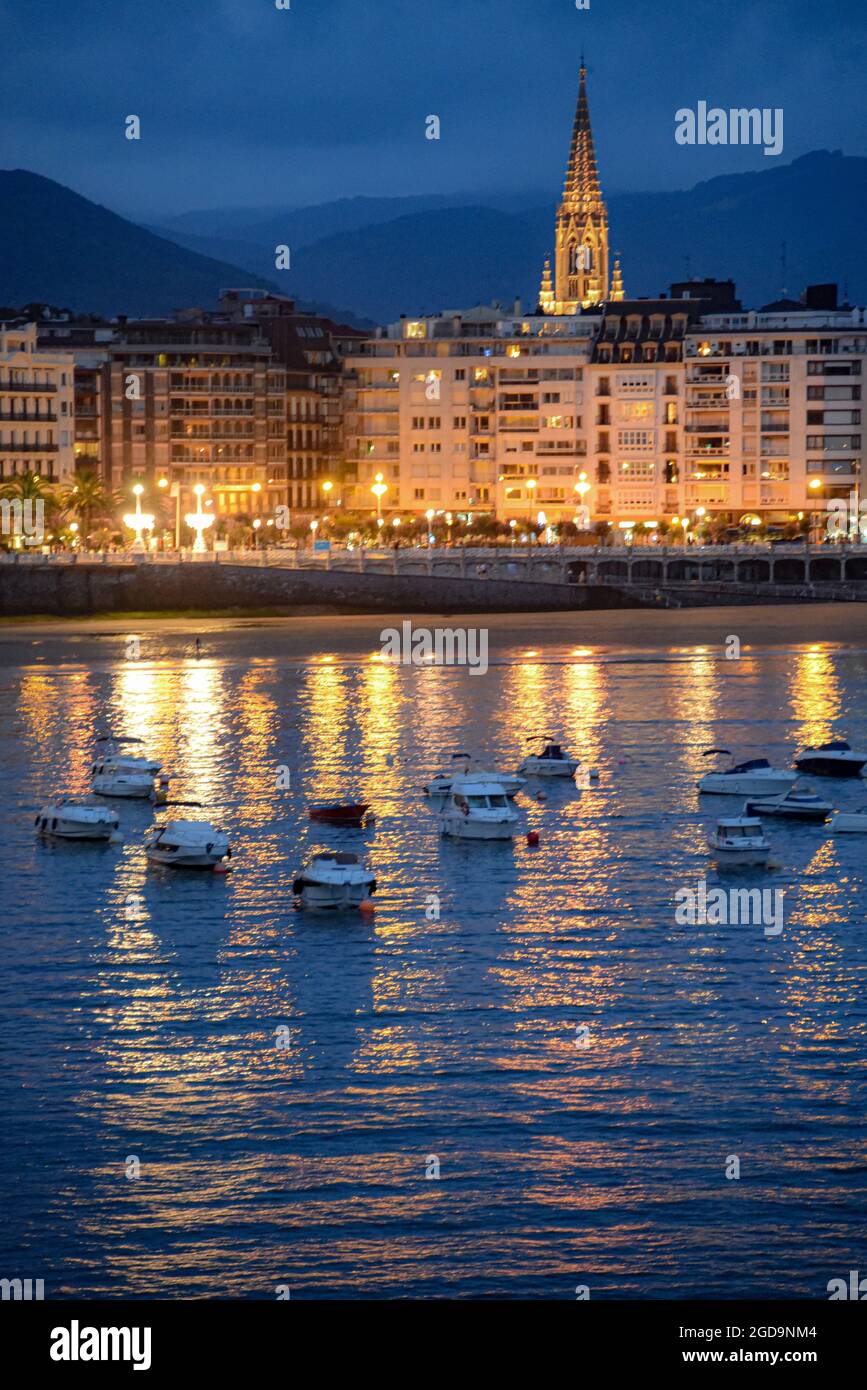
[542,58,622,314]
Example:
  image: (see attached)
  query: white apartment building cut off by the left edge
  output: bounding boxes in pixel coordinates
[0,324,75,482]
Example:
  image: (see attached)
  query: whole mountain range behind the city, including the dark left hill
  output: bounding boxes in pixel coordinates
[0,150,867,327]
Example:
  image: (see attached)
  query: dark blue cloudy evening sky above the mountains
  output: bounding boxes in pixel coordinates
[0,0,867,220]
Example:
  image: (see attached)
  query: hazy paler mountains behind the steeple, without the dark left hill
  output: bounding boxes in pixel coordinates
[154,150,867,321]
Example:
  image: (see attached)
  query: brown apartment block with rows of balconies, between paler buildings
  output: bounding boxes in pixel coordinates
[39,289,354,530]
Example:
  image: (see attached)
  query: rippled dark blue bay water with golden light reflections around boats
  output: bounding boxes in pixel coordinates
[0,619,867,1298]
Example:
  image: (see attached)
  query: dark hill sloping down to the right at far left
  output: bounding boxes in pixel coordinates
[0,170,275,317]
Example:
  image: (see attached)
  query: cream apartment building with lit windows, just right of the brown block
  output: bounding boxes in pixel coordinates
[343,303,596,518]
